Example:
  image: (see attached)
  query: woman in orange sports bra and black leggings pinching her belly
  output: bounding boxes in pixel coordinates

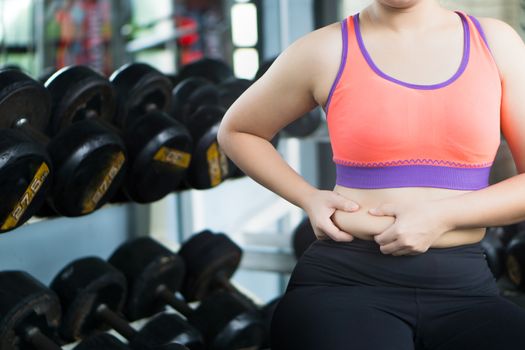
[219,0,525,350]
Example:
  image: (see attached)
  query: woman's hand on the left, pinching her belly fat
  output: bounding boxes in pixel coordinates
[302,190,359,242]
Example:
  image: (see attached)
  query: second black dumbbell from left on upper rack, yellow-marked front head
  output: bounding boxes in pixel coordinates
[41,66,127,216]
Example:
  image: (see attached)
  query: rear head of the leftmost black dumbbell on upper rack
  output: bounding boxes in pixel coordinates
[0,69,51,131]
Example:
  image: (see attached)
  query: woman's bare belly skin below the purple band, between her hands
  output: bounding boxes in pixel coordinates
[332,186,485,248]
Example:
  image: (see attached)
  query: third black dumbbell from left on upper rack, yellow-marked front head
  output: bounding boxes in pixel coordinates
[110,63,192,203]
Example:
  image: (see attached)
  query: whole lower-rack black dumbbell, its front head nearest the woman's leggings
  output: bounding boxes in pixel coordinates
[109,237,264,350]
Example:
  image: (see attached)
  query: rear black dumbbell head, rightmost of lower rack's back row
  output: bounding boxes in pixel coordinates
[179,231,242,301]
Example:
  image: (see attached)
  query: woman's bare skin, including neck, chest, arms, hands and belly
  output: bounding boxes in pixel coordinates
[219,0,525,255]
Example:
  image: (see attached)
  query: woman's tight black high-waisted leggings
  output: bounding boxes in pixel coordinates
[271,239,525,350]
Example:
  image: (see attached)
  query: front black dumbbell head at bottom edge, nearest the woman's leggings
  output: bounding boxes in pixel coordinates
[188,291,264,350]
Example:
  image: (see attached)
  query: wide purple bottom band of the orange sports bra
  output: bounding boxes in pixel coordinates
[336,164,490,191]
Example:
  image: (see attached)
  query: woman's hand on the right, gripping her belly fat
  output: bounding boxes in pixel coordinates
[369,201,453,256]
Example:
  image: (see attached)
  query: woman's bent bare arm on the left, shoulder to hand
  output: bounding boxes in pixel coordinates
[218,25,356,240]
